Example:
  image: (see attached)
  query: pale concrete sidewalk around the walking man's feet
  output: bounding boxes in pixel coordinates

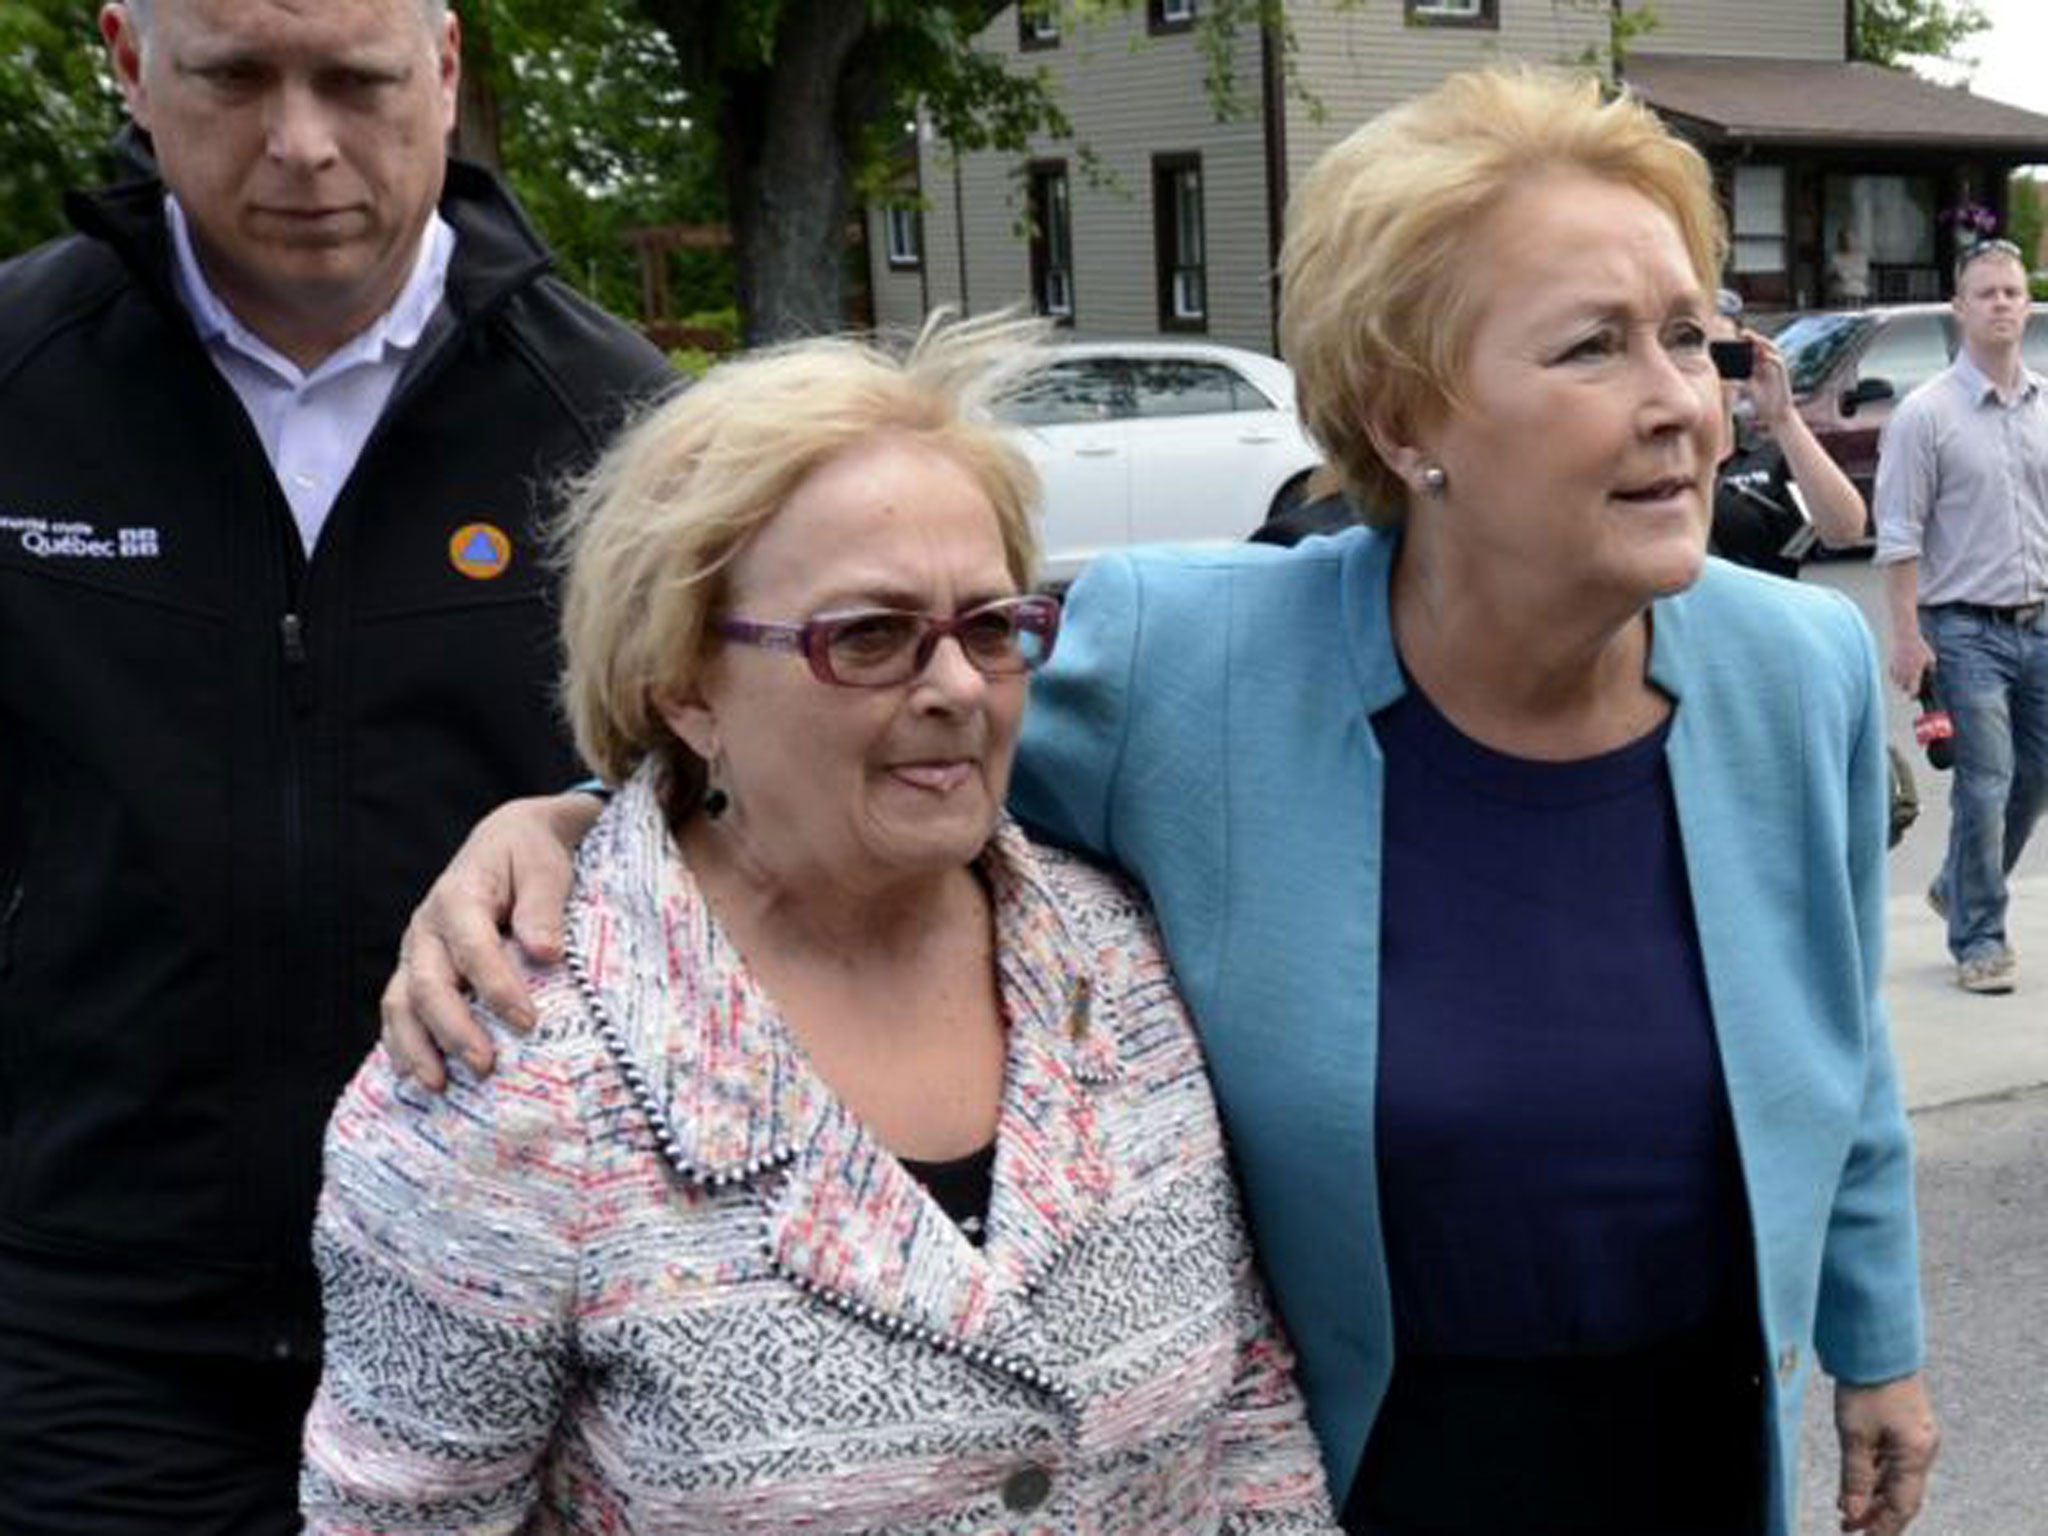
[1884,874,2048,1110]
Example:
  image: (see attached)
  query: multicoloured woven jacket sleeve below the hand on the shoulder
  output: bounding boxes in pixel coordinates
[299,991,588,1536]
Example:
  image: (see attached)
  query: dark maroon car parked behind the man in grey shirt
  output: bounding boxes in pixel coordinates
[1774,303,2048,520]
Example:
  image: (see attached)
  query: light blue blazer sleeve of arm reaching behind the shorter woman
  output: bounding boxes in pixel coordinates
[1010,555,1143,862]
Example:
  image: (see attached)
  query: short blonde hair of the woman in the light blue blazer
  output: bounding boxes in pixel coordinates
[1280,68,1729,524]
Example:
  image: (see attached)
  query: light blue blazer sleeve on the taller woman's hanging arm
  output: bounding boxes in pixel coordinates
[1815,612,1925,1382]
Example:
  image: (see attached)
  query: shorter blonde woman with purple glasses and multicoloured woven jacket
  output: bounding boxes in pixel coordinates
[303,324,1335,1536]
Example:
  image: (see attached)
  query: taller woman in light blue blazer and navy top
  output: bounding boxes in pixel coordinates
[387,72,1935,1536]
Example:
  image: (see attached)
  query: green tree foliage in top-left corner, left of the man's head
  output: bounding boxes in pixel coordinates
[0,0,121,256]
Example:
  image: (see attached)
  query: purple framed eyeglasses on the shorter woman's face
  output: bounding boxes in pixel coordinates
[713,594,1059,688]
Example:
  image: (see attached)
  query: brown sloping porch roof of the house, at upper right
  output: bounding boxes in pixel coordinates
[1622,53,2048,164]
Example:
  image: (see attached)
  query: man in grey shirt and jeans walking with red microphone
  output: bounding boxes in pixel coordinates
[1876,240,2048,993]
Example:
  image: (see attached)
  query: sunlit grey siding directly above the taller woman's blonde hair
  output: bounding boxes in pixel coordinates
[1286,0,1605,186]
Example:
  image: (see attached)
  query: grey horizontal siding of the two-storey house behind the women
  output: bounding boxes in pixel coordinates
[870,0,1818,350]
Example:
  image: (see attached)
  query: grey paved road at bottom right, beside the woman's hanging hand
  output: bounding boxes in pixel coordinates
[1800,1081,2048,1536]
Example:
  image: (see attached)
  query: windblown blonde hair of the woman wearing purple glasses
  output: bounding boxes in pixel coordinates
[555,315,1047,798]
